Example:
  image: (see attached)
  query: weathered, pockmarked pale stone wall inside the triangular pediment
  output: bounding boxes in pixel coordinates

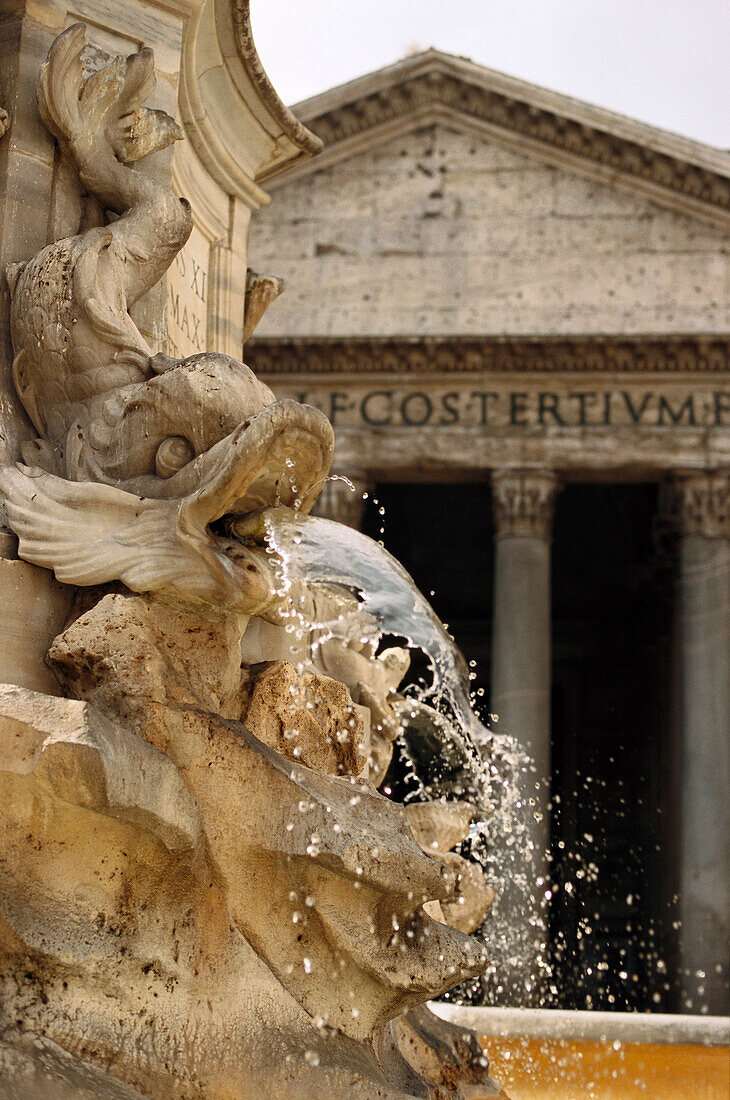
[250,125,730,337]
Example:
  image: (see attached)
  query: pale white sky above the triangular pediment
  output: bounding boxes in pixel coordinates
[251,0,730,149]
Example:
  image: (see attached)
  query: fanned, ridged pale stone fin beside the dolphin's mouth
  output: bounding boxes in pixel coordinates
[0,465,185,592]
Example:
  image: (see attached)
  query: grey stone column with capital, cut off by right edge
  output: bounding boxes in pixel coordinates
[675,471,730,1015]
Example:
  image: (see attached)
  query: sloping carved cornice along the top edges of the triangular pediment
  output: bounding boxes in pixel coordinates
[275,50,730,227]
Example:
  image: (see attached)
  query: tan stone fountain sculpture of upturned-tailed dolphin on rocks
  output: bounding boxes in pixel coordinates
[0,24,498,1100]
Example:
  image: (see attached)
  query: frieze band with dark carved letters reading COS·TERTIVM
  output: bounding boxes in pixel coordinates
[279,380,730,430]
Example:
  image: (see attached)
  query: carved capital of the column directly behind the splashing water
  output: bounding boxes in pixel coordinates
[491,468,558,539]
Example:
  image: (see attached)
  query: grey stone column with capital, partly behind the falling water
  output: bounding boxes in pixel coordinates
[491,469,557,1004]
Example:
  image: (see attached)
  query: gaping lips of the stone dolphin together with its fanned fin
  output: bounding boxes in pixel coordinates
[0,400,334,614]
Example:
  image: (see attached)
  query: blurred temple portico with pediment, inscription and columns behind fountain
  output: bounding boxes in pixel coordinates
[241,51,730,1012]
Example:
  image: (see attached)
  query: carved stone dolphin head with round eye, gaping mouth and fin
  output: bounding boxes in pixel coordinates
[0,354,333,614]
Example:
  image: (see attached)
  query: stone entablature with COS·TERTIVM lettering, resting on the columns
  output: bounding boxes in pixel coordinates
[246,339,730,481]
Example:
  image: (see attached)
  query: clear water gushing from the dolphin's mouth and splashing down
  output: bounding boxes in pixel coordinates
[249,508,542,1003]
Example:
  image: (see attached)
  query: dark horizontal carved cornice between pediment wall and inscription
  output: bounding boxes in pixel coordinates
[245,336,730,375]
